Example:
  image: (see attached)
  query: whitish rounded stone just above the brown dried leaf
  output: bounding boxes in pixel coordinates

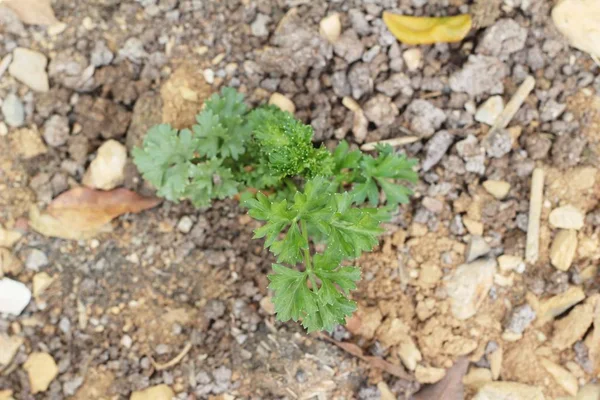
[82,140,127,190]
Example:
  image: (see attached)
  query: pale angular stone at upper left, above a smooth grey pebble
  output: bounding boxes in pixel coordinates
[8,47,50,92]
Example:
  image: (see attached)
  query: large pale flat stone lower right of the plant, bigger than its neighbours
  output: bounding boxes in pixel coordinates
[446,259,496,320]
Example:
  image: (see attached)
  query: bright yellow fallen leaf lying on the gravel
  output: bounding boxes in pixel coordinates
[383,11,472,44]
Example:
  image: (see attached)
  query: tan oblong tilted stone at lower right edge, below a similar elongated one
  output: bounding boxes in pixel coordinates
[551,302,594,350]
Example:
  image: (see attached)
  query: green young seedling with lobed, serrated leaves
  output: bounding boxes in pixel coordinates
[133,88,417,332]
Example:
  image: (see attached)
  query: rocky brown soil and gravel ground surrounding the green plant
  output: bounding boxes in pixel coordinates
[0,0,600,400]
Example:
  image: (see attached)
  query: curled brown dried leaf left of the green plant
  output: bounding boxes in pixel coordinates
[29,187,161,239]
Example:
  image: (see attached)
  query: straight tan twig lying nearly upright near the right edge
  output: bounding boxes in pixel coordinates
[525,168,544,264]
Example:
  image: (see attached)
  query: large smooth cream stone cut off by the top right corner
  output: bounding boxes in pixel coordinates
[552,0,600,58]
